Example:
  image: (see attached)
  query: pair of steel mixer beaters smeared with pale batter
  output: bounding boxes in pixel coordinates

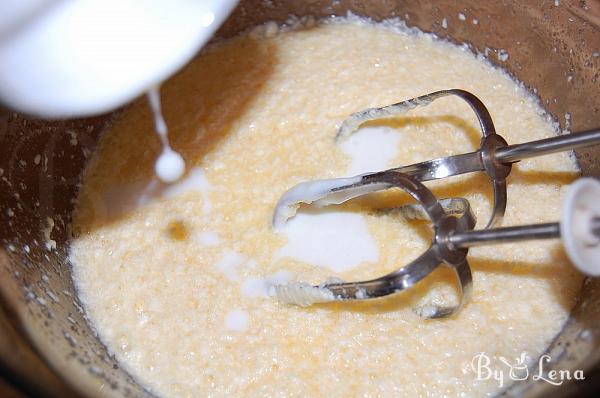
[273,89,600,318]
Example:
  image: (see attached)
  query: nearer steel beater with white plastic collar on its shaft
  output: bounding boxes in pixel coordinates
[275,170,600,318]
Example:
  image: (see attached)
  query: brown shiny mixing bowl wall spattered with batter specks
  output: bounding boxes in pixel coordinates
[0,0,600,397]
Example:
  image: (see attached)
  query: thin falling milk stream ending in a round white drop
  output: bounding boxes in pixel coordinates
[147,86,185,183]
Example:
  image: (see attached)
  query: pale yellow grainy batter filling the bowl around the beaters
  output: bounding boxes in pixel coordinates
[71,20,582,397]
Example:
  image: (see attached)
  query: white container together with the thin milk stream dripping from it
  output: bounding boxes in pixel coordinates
[0,0,237,183]
